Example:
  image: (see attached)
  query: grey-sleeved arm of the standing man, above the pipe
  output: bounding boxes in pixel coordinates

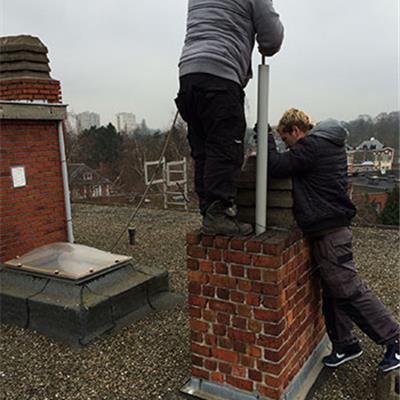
[253,0,284,57]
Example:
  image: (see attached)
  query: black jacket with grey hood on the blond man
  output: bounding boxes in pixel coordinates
[268,119,356,234]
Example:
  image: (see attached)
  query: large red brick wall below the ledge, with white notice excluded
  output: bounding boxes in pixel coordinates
[0,120,67,262]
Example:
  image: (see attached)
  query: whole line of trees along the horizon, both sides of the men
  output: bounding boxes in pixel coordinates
[66,111,400,203]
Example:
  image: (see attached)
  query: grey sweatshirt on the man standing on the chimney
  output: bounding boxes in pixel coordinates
[179,0,283,87]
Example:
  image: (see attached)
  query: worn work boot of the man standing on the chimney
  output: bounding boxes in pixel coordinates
[201,200,253,236]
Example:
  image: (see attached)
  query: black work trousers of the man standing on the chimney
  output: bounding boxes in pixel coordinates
[175,74,246,214]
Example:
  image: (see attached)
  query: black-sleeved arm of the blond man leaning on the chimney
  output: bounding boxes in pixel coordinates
[268,134,317,178]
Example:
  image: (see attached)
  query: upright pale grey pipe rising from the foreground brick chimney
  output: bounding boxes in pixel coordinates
[256,57,269,235]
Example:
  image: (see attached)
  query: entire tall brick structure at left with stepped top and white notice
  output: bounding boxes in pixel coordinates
[0,35,67,262]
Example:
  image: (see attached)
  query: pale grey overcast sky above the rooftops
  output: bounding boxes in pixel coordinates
[0,0,399,129]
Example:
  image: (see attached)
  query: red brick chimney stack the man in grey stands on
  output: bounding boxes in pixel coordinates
[187,231,325,399]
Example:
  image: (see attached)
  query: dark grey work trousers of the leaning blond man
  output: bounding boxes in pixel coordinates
[311,227,400,352]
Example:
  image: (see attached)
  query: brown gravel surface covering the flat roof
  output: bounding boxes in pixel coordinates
[0,205,400,400]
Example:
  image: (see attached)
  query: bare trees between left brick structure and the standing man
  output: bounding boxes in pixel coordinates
[66,119,193,193]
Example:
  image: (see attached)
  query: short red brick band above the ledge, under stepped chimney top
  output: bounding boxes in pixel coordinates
[0,78,61,103]
